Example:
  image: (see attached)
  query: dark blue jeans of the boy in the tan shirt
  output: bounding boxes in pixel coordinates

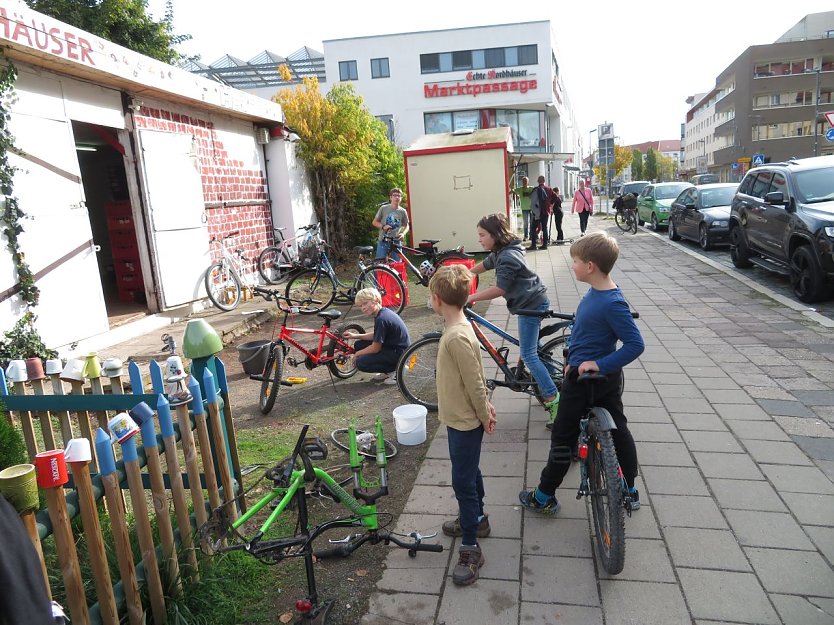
[446,425,484,545]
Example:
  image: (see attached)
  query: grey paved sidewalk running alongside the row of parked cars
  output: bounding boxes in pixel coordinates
[362,215,834,625]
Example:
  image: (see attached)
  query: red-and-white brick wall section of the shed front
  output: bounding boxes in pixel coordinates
[135,106,272,271]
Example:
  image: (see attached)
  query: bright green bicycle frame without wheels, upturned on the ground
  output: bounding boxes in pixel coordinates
[198,416,443,625]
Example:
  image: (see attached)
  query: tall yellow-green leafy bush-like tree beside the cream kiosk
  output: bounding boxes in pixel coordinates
[273,74,405,253]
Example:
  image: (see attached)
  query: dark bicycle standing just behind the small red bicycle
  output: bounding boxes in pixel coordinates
[286,241,406,315]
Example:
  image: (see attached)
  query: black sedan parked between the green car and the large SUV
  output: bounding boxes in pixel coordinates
[669,182,738,250]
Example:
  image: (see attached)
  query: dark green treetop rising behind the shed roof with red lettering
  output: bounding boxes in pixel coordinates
[26,0,191,63]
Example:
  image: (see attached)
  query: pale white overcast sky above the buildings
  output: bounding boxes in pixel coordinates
[149,0,834,149]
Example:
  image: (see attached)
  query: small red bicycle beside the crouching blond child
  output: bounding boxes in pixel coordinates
[249,287,365,414]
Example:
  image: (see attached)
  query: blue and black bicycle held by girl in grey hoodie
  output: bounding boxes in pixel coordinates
[397,308,573,410]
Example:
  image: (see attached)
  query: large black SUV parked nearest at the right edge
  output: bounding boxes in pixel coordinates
[730,155,834,302]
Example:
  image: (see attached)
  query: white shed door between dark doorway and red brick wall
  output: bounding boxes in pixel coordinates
[139,130,210,308]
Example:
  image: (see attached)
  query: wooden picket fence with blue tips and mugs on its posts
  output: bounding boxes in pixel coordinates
[0,356,245,625]
